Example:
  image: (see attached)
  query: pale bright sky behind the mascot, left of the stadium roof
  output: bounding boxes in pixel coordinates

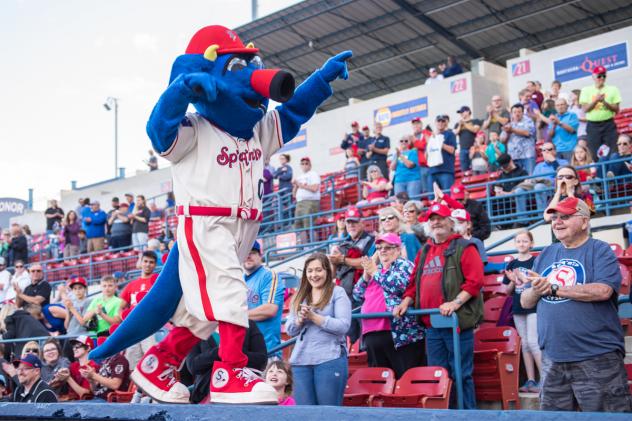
[0,0,297,210]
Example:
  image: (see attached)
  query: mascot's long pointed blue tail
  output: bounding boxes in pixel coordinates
[90,242,182,361]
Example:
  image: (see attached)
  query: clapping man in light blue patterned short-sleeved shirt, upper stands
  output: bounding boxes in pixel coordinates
[500,104,535,174]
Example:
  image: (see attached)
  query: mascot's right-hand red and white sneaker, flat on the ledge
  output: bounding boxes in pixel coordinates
[211,361,279,405]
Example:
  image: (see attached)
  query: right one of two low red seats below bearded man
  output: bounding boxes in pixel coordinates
[370,367,452,409]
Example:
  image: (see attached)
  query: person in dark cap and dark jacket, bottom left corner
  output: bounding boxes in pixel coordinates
[11,354,57,403]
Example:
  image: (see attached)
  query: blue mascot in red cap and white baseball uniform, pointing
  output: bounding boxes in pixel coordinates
[90,26,352,404]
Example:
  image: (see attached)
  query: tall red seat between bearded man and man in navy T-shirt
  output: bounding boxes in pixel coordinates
[473,327,520,410]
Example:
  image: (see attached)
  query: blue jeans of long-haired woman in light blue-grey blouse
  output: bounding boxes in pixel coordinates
[292,354,349,406]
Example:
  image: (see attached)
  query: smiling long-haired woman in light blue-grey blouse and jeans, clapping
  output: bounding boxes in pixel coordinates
[285,253,351,406]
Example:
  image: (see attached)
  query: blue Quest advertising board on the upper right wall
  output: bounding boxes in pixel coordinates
[553,42,628,82]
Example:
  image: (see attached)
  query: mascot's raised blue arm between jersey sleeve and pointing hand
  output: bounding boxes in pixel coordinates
[276,70,334,144]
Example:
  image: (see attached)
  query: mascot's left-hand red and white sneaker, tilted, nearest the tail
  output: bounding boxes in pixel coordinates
[130,345,190,403]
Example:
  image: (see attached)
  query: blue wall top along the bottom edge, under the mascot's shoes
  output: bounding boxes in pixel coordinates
[0,402,632,421]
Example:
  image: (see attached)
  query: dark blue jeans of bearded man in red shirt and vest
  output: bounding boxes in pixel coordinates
[426,328,476,409]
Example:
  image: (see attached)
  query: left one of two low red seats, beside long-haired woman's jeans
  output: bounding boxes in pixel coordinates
[342,367,395,406]
